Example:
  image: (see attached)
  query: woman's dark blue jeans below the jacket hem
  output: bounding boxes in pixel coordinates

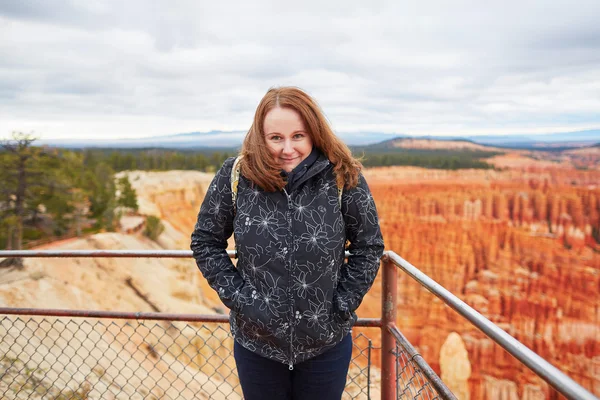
[233,335,352,400]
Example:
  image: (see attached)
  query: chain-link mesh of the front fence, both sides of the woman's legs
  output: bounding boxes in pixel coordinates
[0,316,379,399]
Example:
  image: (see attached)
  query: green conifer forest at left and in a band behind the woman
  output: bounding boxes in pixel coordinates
[0,132,496,250]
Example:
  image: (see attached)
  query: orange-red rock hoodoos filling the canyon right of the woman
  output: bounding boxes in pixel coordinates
[359,168,600,399]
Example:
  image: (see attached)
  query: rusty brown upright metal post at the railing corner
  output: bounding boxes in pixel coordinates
[381,254,398,400]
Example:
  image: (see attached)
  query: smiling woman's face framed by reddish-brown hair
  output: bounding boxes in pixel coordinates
[263,107,312,172]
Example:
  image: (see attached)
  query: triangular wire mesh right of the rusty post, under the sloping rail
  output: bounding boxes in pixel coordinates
[394,343,440,400]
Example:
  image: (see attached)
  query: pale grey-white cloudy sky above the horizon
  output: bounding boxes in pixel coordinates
[0,0,600,139]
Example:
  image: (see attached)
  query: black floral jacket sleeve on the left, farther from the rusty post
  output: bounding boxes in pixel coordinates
[190,158,244,308]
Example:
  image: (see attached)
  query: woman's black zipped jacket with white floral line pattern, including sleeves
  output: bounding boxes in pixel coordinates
[191,155,383,368]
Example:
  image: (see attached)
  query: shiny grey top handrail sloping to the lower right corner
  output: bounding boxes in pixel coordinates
[384,250,598,400]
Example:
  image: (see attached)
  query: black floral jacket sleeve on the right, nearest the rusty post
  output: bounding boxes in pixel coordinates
[334,174,384,319]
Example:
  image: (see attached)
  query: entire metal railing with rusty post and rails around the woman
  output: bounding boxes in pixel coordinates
[0,250,597,400]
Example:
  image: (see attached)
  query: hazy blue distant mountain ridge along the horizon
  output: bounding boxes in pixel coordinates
[39,129,600,150]
